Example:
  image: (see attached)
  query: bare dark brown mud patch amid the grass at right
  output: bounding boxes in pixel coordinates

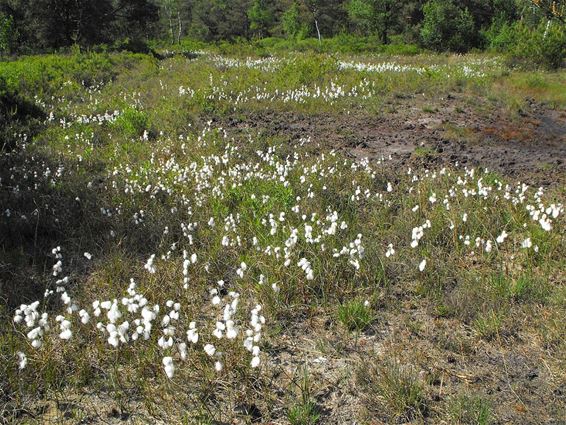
[219,96,566,186]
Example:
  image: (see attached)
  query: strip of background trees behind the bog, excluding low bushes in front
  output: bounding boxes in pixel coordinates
[0,0,566,53]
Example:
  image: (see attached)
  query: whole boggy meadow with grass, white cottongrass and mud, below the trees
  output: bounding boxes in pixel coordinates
[0,50,566,425]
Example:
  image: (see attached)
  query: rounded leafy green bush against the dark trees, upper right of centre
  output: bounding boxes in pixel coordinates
[421,0,475,52]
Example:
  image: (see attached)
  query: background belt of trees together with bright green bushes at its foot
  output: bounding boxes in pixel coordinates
[0,0,566,69]
